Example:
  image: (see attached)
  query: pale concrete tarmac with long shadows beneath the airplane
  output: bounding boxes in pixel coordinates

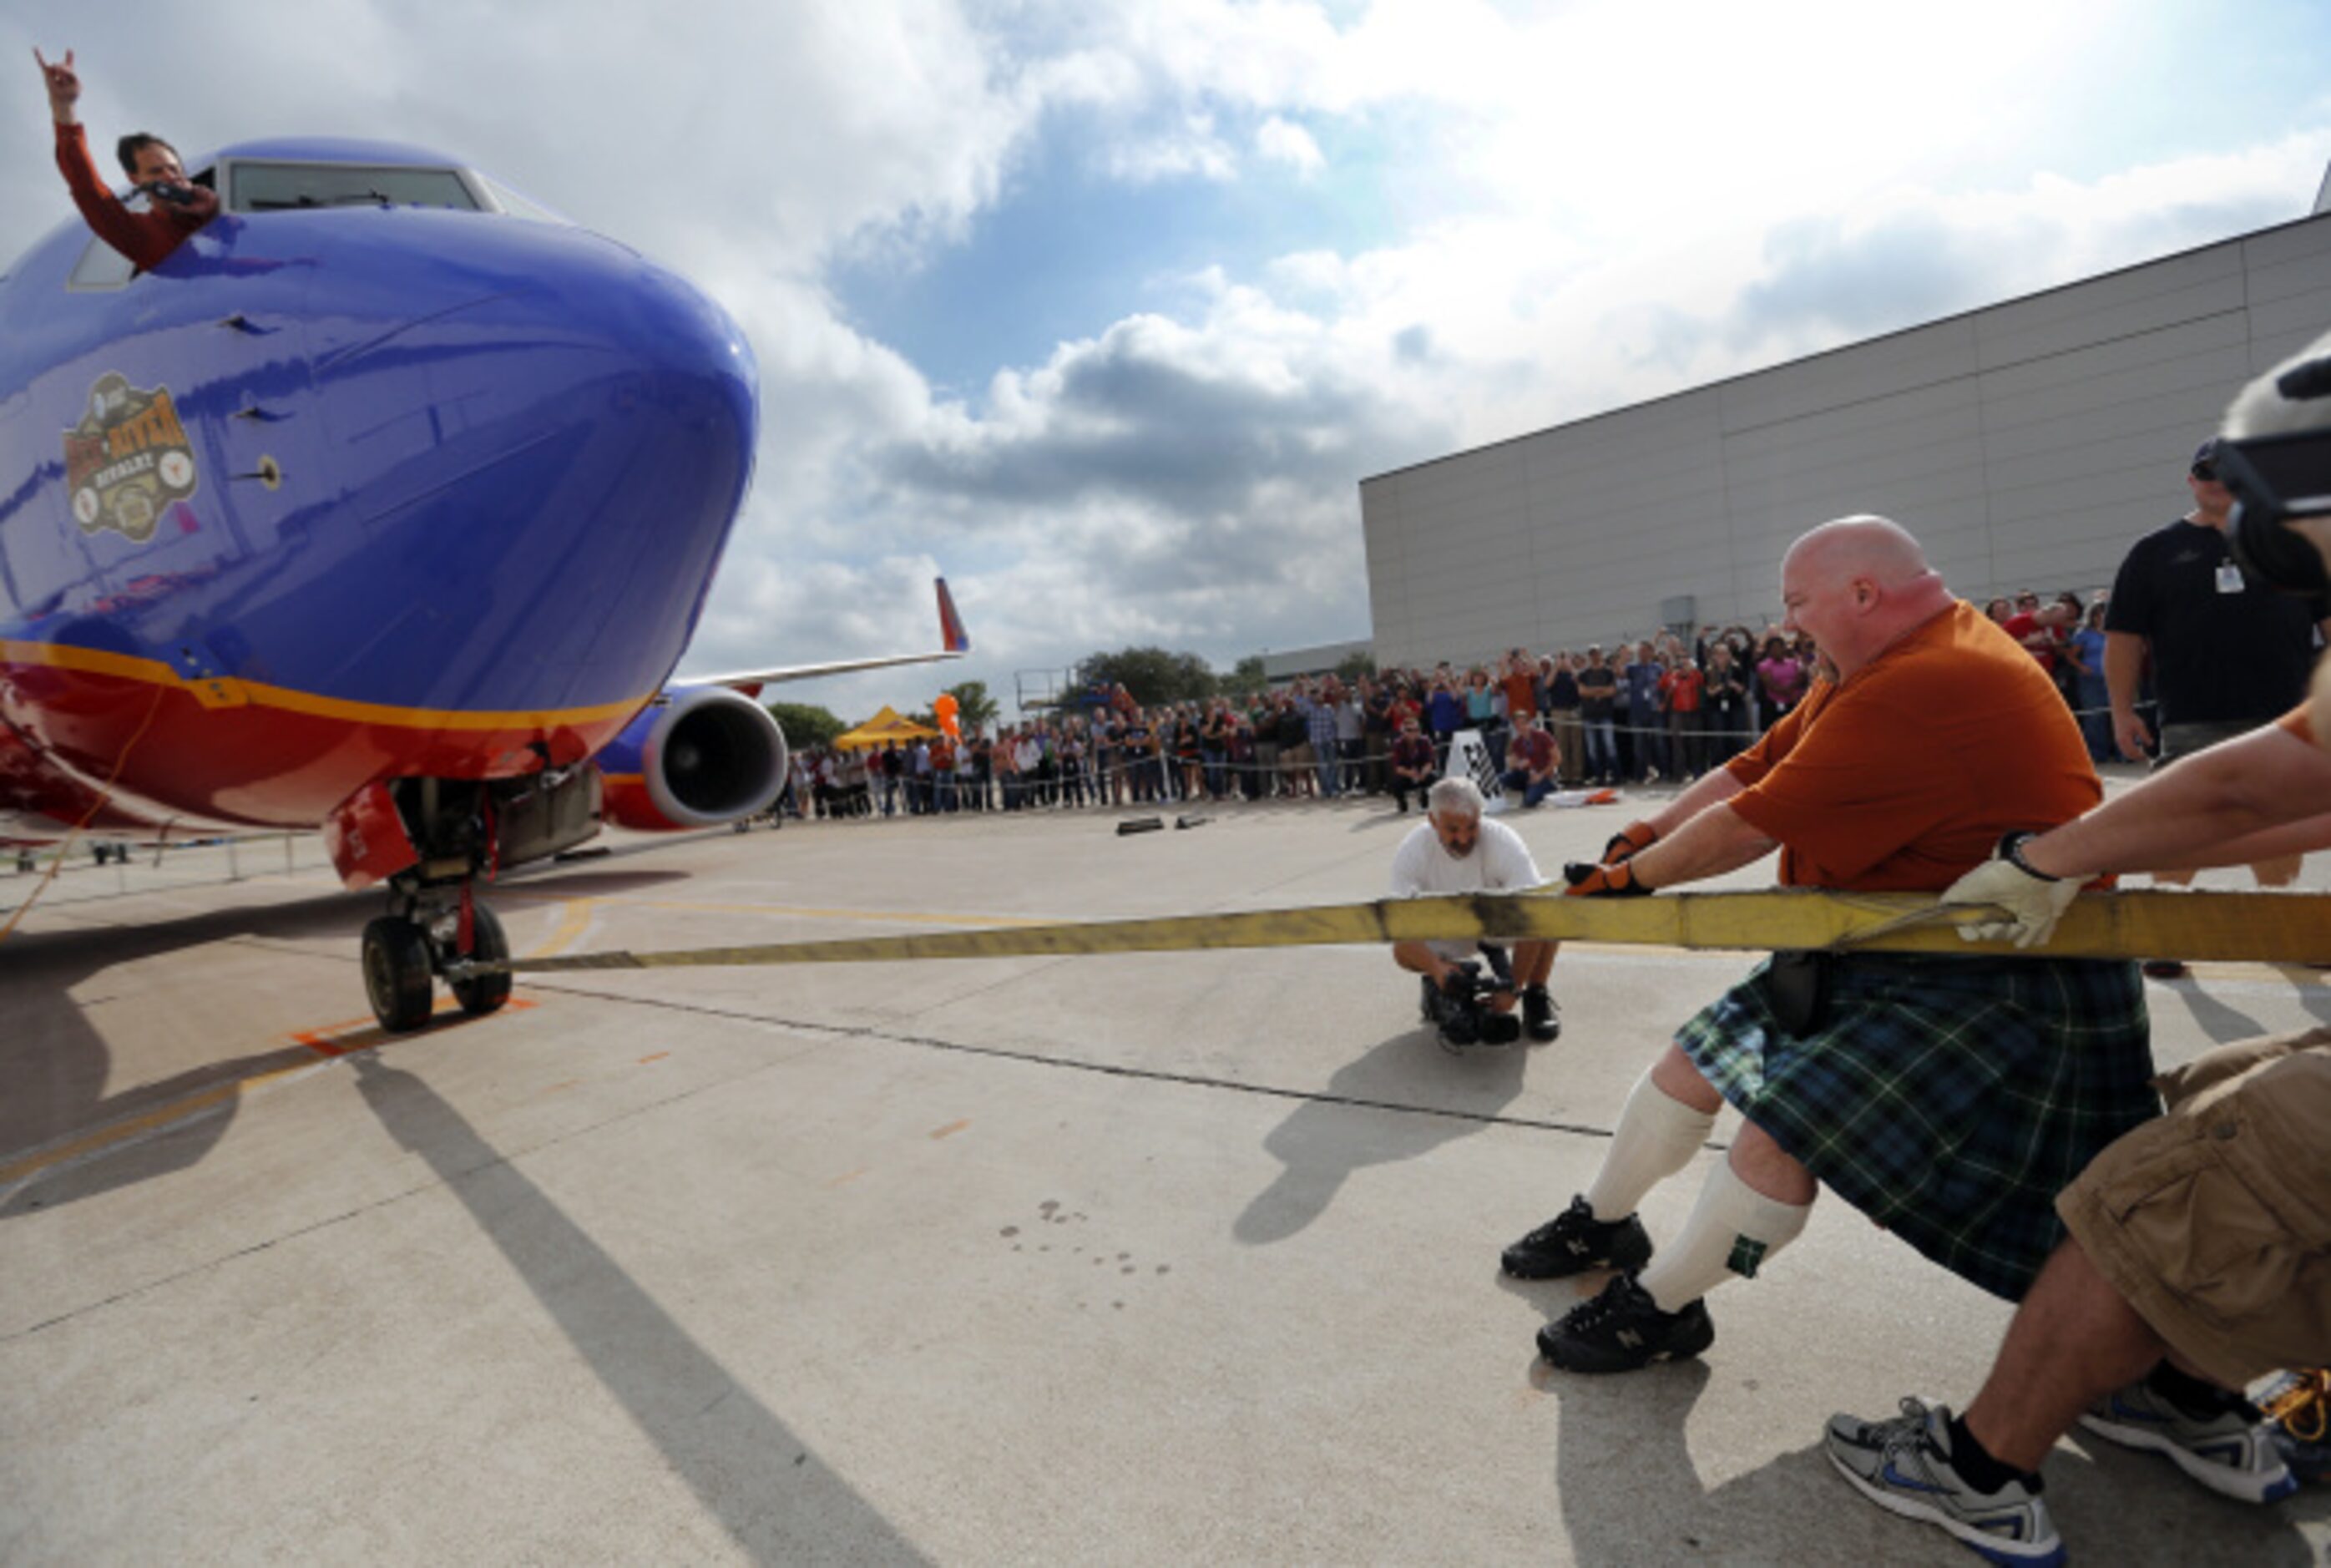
[0,802,2331,1563]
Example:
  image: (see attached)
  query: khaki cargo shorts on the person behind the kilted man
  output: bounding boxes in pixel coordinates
[2056,1028,2331,1388]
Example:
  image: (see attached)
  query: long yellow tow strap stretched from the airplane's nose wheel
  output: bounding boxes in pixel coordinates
[447,888,2331,979]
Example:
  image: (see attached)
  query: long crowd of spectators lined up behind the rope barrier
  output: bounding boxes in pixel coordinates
[788,592,2112,816]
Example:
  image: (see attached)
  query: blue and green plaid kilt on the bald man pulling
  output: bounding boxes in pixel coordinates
[1676,953,2161,1300]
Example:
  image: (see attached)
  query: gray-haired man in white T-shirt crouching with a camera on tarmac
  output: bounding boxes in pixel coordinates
[1392,778,1562,1049]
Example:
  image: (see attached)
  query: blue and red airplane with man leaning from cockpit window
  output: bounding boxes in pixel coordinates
[0,139,969,1029]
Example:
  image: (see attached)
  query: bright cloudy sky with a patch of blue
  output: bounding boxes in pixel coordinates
[0,0,2331,717]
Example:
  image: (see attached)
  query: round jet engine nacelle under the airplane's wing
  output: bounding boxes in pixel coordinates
[599,685,786,832]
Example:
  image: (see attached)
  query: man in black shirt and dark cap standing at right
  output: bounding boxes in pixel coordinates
[2105,438,2331,979]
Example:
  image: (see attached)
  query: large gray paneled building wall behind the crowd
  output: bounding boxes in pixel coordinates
[1359,215,2331,664]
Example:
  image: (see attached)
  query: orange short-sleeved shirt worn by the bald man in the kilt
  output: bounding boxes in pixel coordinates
[1727,604,2105,893]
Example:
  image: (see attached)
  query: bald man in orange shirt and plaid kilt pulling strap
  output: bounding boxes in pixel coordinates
[1504,517,2158,1373]
